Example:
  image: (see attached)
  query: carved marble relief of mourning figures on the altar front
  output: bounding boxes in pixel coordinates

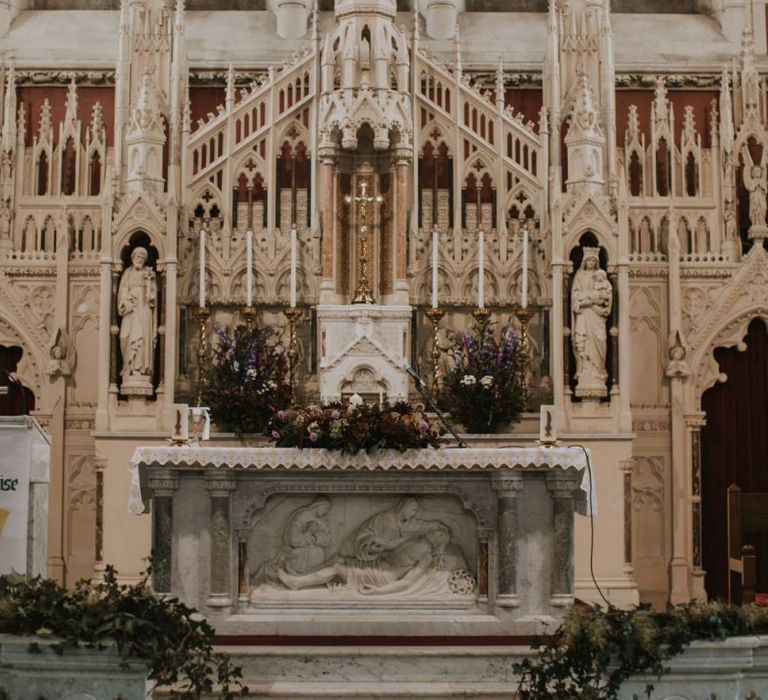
[248,494,478,607]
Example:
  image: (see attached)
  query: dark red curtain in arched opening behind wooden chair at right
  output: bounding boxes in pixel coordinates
[701,317,768,598]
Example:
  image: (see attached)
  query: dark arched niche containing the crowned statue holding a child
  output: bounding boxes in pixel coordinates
[564,232,618,401]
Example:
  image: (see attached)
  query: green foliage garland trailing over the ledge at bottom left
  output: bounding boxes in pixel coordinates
[0,566,248,700]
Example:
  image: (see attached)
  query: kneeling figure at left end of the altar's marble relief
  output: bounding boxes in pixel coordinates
[254,496,333,583]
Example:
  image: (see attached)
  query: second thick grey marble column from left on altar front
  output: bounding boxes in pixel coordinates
[205,476,236,608]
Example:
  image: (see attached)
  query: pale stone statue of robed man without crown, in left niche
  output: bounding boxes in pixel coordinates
[117,246,157,395]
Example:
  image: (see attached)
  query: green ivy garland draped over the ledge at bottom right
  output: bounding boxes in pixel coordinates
[515,601,768,700]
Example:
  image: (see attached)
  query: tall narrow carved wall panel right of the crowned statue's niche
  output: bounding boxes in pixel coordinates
[629,286,664,407]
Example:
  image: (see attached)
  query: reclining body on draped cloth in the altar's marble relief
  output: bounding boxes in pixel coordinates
[278,521,475,595]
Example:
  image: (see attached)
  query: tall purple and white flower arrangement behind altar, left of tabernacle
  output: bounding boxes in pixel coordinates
[204,326,291,437]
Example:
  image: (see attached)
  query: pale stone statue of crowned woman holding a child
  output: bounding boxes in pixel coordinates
[571,246,613,399]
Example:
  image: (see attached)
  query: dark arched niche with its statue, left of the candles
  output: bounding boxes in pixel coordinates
[113,232,162,397]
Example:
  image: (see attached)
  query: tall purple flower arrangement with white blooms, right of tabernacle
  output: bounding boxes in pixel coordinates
[440,324,523,433]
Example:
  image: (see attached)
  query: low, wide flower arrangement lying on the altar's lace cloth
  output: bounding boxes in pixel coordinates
[267,395,439,454]
